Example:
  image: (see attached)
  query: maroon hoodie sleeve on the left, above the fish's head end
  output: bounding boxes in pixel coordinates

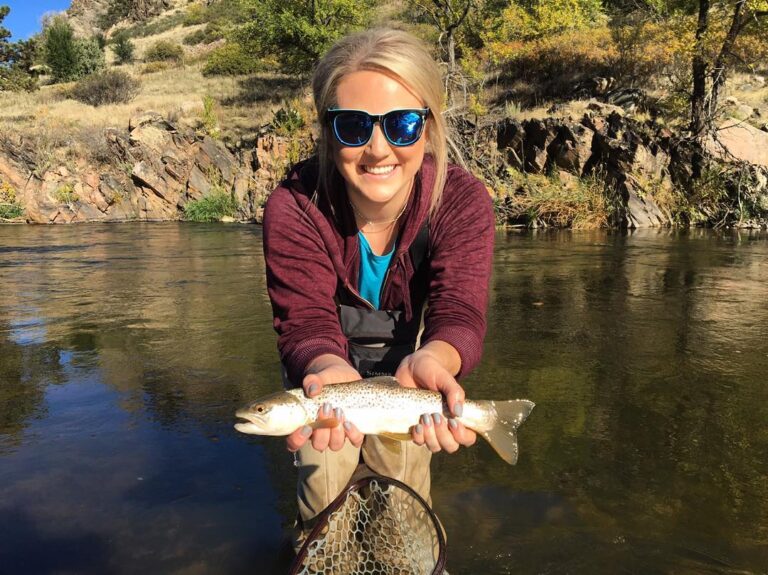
[263,186,347,385]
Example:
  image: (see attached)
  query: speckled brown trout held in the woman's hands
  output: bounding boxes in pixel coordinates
[235,377,534,465]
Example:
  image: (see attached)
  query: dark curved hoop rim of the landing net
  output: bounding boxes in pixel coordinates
[289,475,446,575]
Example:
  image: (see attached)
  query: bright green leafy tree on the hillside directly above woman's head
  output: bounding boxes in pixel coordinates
[233,0,373,74]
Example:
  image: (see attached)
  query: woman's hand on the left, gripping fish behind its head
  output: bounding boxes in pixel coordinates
[286,354,365,451]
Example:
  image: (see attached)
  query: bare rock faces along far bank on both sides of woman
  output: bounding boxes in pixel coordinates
[0,103,768,228]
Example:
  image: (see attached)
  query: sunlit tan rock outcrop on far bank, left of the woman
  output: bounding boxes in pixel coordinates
[0,112,288,224]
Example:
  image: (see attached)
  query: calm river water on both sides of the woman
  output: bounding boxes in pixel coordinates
[0,223,768,575]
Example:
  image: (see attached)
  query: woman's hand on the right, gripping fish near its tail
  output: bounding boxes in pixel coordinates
[395,341,477,453]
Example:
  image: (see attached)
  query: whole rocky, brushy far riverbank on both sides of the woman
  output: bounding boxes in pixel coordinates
[0,99,768,228]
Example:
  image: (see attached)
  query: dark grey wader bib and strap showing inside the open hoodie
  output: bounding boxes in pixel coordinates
[338,222,429,378]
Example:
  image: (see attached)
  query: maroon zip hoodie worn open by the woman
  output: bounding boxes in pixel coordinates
[264,155,494,383]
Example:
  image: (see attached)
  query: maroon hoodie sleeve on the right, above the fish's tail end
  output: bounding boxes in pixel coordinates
[422,167,495,378]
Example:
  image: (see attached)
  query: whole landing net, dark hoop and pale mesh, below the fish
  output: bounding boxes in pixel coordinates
[291,476,445,575]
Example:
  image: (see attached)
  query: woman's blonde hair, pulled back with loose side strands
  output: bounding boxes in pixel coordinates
[312,28,448,216]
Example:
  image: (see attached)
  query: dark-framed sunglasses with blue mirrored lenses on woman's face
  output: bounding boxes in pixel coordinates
[325,108,429,148]
